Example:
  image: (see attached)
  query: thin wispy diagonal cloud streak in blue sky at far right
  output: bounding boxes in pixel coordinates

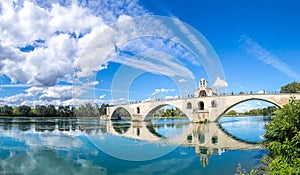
[240,35,300,80]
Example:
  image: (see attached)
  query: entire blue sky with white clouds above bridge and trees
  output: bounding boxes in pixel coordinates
[0,0,300,111]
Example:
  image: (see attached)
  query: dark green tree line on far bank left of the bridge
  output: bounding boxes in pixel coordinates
[0,103,109,117]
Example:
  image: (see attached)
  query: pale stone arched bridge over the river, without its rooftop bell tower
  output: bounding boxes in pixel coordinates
[107,94,300,122]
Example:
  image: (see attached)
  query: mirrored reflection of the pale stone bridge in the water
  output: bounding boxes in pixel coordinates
[96,121,262,167]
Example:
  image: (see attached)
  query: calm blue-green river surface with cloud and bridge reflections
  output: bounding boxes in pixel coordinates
[0,116,268,175]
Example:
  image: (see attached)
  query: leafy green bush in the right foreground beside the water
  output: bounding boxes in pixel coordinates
[264,100,300,175]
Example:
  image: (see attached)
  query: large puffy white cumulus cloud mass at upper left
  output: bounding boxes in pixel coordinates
[0,0,104,86]
